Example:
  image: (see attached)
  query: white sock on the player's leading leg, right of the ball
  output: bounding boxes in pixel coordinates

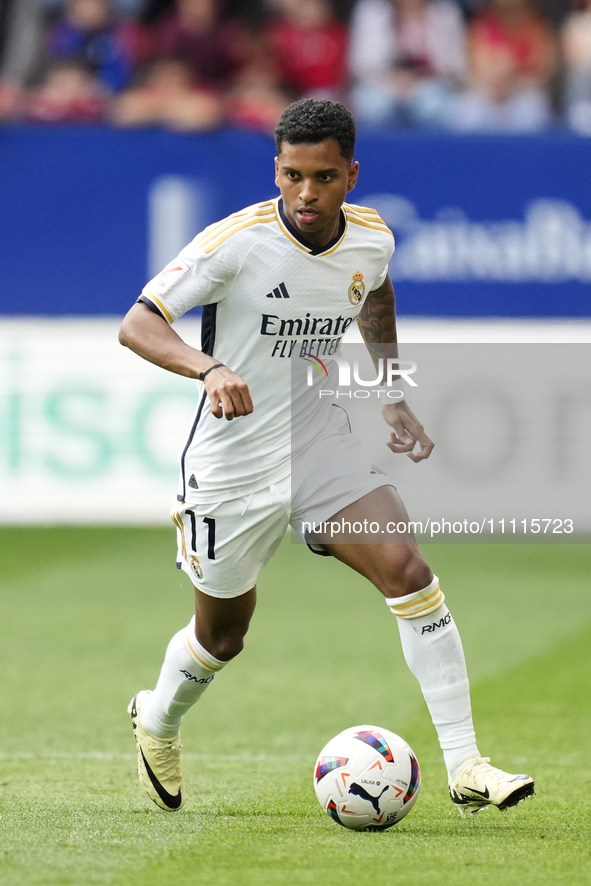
[386,576,478,778]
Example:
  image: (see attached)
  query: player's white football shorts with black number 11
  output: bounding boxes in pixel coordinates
[172,432,391,598]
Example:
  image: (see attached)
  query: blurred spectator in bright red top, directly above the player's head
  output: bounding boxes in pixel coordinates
[266,0,348,98]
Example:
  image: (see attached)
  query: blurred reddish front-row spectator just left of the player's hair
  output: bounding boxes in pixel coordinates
[228,62,297,134]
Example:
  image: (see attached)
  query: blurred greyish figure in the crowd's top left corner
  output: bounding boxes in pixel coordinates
[0,0,44,118]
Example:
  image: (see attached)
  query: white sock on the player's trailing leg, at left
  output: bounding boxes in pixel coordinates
[141,617,227,738]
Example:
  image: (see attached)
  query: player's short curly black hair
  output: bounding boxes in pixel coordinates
[275,98,356,162]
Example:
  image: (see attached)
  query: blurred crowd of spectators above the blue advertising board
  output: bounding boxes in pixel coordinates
[0,0,591,135]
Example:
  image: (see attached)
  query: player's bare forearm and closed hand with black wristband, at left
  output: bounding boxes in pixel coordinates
[119,302,253,421]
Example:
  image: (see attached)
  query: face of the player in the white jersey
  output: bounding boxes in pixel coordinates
[275,138,359,246]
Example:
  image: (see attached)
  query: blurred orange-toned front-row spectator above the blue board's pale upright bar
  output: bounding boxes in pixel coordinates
[111,59,223,132]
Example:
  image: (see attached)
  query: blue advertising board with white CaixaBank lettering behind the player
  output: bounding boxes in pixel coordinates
[0,127,591,317]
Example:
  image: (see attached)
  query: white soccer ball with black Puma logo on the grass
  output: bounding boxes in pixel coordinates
[314,726,421,831]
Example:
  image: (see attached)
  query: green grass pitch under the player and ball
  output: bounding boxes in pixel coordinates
[0,528,591,886]
